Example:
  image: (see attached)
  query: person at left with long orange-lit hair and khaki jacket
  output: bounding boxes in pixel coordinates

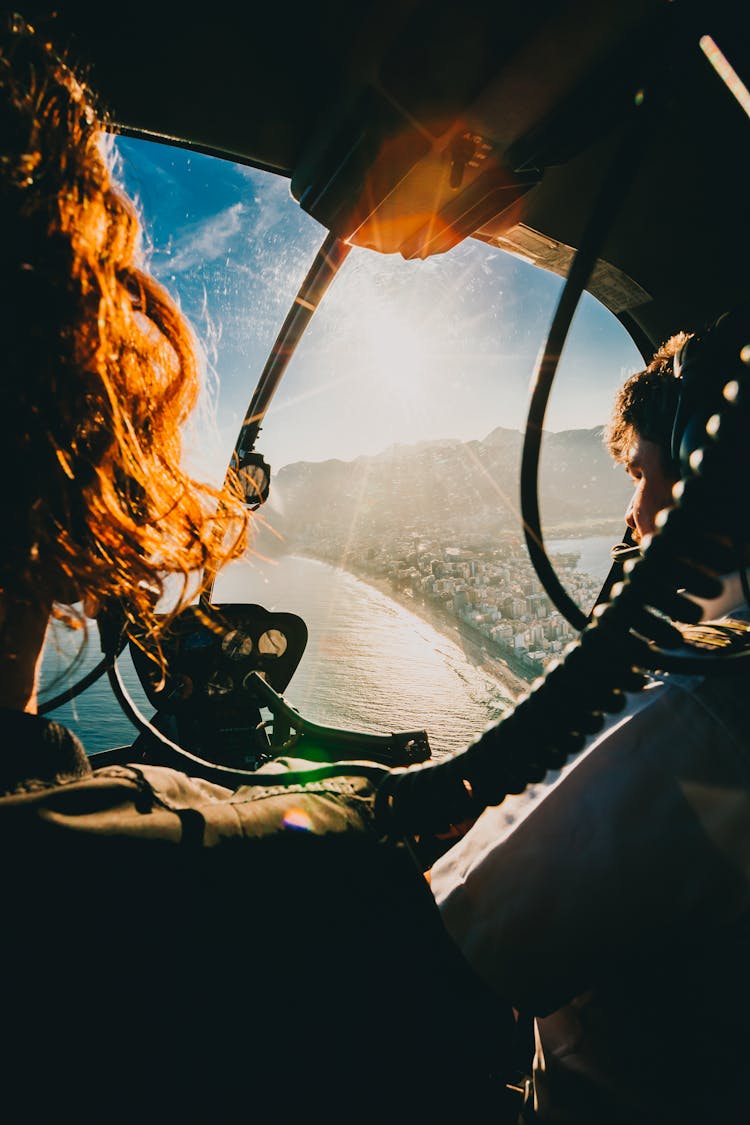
[0,15,517,1123]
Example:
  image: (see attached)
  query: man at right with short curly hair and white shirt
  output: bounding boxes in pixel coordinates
[431,321,750,1125]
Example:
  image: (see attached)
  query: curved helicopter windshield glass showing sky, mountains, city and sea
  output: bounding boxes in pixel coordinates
[42,137,642,755]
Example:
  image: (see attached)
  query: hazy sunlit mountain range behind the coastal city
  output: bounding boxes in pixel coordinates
[259,426,632,546]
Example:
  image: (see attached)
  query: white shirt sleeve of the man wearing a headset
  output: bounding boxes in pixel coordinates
[432,677,750,1015]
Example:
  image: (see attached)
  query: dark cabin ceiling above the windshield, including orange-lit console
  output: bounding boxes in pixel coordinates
[20,0,750,353]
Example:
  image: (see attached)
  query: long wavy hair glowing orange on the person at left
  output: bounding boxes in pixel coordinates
[0,16,247,643]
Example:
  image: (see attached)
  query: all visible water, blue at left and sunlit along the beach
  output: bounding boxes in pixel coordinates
[40,537,612,759]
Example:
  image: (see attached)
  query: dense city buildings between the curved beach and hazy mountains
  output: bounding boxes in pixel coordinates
[297,532,602,681]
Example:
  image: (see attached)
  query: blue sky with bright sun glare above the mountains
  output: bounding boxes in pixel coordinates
[117,137,641,478]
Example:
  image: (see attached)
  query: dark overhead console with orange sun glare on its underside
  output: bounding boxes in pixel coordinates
[291,0,665,259]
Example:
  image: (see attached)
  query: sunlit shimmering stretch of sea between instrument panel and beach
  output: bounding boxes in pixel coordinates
[212,557,512,756]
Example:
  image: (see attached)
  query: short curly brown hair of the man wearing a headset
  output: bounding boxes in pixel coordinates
[604,332,689,471]
